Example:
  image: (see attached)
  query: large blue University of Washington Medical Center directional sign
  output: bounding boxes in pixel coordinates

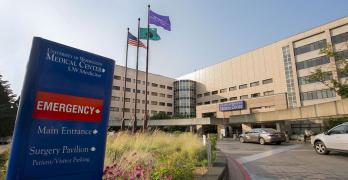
[7,37,115,180]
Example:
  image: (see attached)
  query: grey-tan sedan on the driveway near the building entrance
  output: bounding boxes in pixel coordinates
[239,128,286,145]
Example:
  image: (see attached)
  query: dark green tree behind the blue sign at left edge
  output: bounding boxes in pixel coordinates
[0,75,19,137]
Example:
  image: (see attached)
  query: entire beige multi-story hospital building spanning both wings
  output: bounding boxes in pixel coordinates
[111,17,348,131]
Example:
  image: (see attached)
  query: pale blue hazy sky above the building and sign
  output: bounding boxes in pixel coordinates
[0,0,348,95]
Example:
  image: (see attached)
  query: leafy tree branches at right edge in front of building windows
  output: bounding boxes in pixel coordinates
[308,43,348,98]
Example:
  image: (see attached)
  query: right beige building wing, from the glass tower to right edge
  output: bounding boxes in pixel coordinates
[179,17,348,118]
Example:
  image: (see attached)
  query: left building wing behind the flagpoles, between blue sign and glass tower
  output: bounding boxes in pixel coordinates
[109,65,175,121]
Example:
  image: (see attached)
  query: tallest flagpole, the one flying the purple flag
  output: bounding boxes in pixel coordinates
[143,4,150,132]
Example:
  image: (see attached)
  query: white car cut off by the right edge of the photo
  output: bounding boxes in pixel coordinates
[311,122,348,155]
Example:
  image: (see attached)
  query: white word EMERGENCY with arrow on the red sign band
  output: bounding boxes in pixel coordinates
[36,101,100,115]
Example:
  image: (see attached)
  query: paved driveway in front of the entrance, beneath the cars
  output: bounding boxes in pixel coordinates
[217,139,348,180]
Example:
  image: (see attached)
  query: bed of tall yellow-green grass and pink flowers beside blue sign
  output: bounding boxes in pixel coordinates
[103,131,207,179]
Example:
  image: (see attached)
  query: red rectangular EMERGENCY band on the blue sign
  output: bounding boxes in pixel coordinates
[33,91,103,122]
